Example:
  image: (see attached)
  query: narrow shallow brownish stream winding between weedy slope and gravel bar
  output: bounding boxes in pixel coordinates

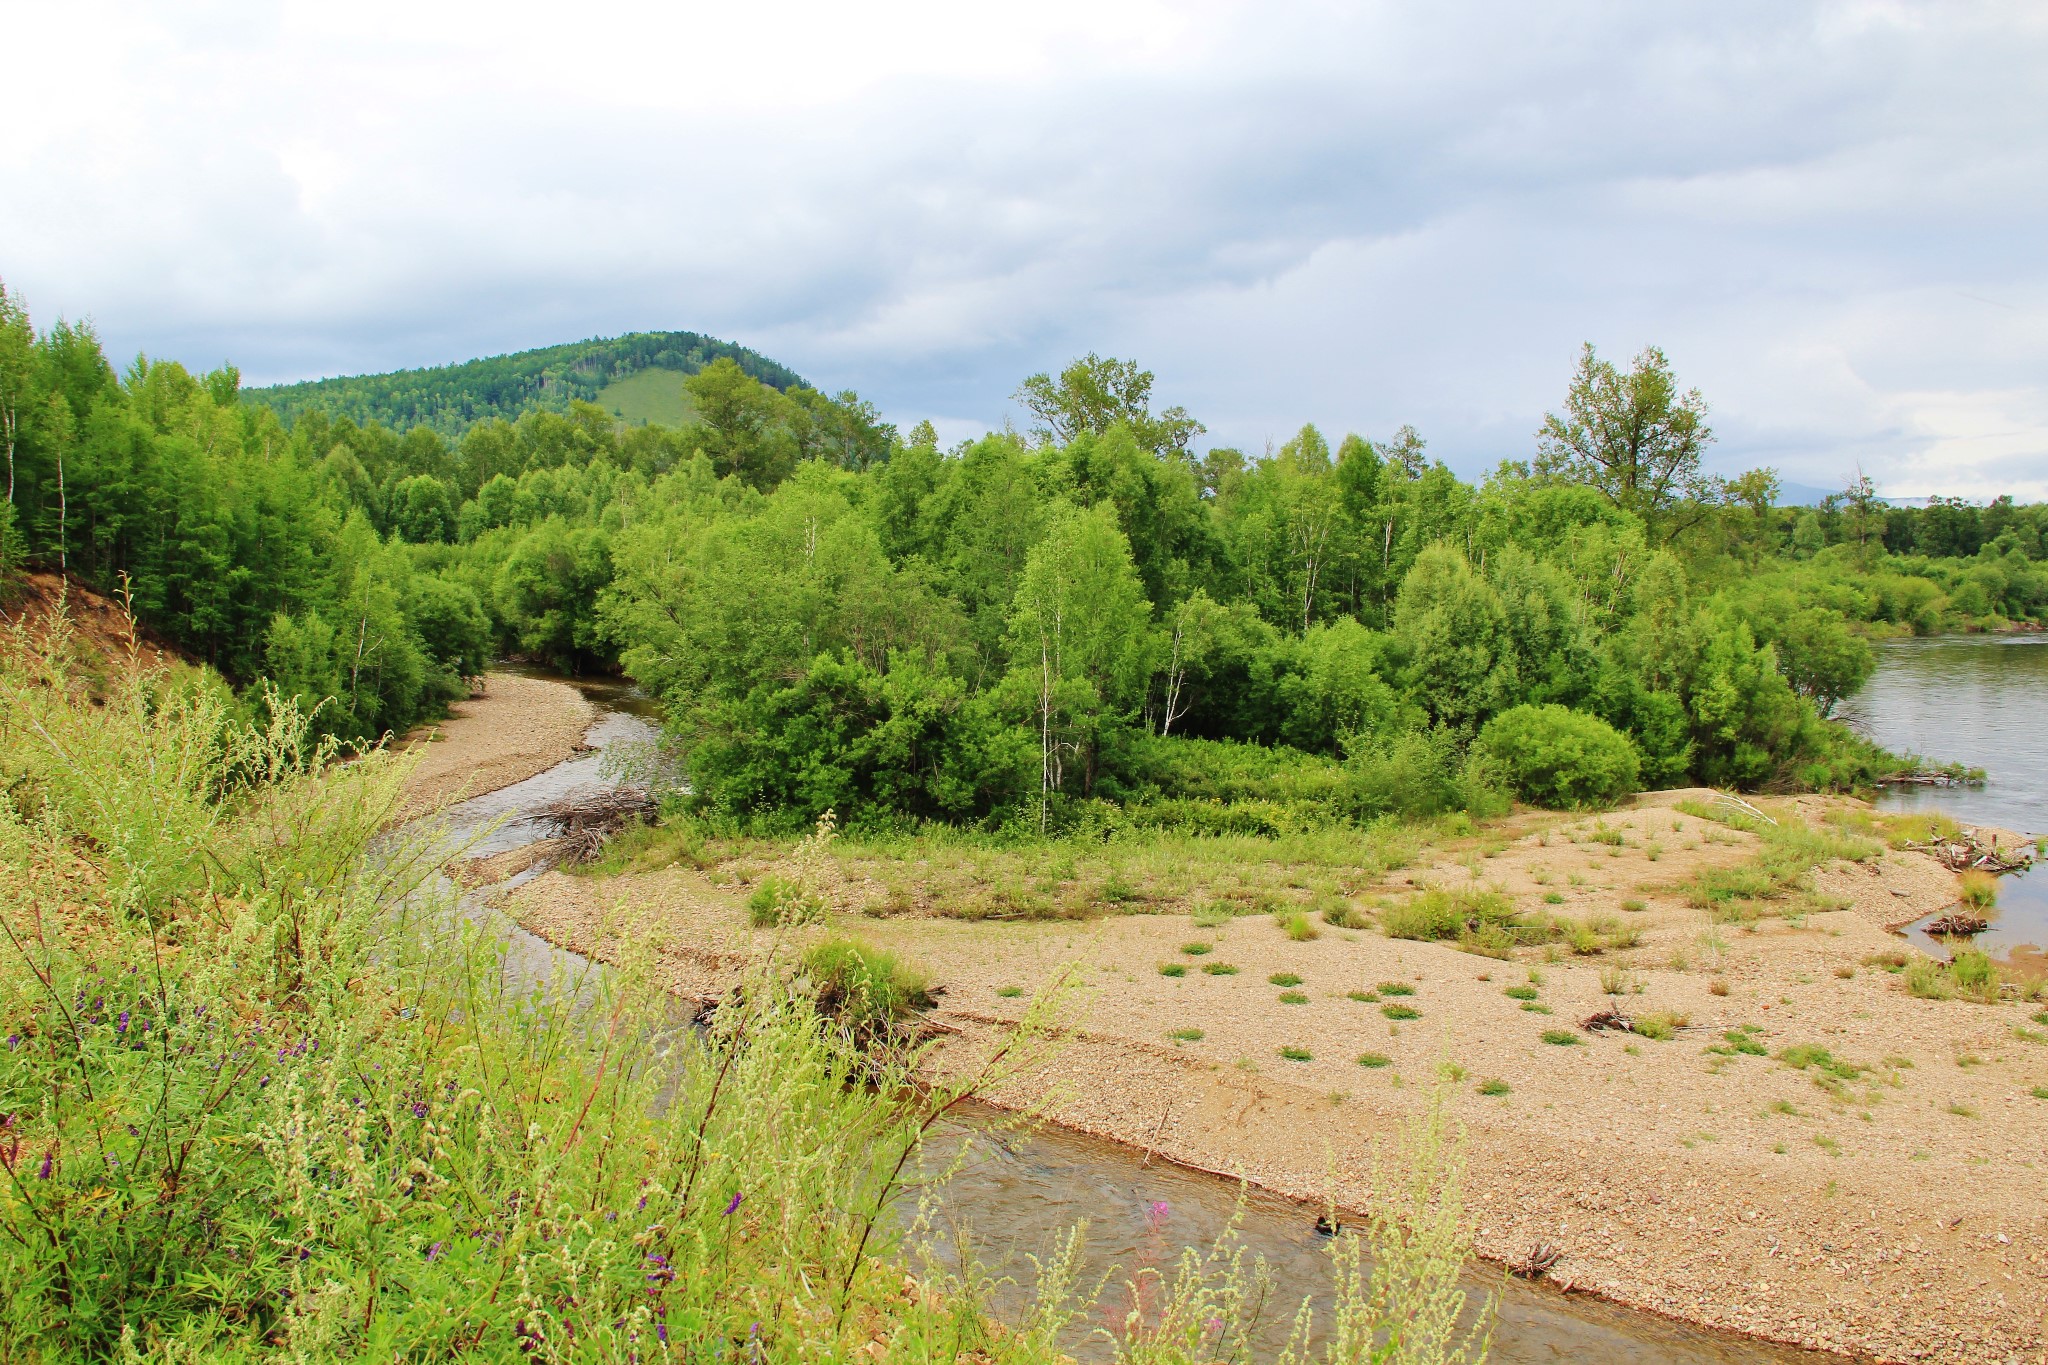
[419,681,1841,1365]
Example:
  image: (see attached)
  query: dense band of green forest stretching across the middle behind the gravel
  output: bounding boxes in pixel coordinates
[0,282,2048,829]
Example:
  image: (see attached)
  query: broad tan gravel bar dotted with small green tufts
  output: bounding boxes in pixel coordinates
[495,794,2048,1361]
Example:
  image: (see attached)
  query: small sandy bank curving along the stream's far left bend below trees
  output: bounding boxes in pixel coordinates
[406,673,598,819]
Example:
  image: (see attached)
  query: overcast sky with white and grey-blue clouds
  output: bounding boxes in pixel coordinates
[0,0,2048,497]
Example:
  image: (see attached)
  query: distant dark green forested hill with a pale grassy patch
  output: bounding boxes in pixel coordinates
[242,332,803,438]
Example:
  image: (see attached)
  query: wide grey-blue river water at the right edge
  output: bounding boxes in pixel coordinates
[1839,634,2048,974]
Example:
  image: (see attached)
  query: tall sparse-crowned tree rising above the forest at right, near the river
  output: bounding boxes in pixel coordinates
[1536,342,1720,538]
